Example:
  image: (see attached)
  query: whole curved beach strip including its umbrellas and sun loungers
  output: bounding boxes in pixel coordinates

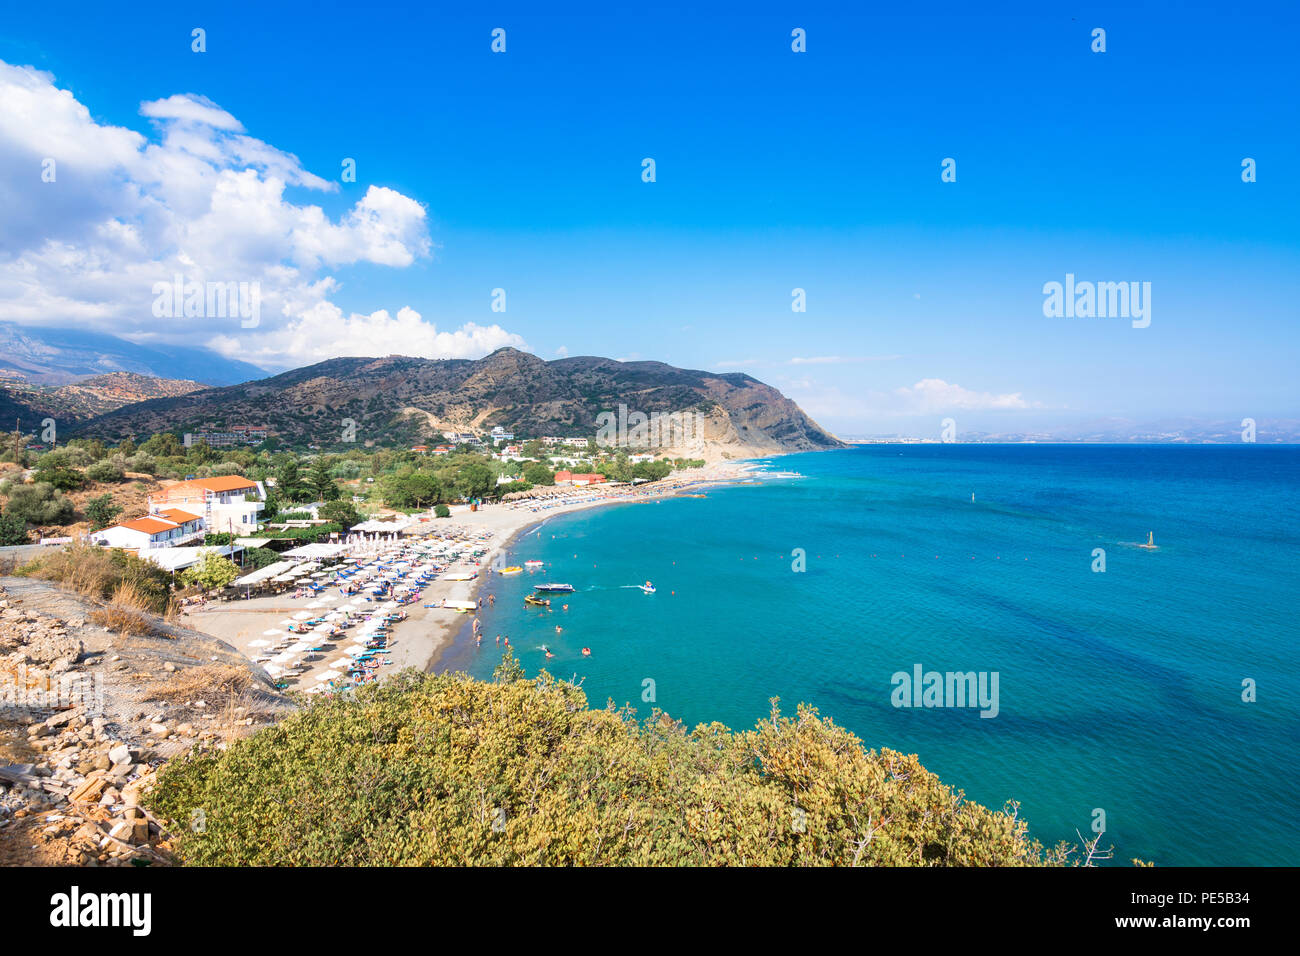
[185,462,761,693]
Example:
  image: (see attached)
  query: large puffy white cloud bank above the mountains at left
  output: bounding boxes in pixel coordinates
[0,61,496,368]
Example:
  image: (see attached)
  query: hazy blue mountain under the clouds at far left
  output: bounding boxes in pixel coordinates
[0,323,267,385]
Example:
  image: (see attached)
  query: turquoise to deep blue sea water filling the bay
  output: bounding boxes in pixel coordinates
[441,445,1300,865]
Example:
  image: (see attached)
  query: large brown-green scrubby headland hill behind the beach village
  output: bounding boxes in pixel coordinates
[79,349,841,458]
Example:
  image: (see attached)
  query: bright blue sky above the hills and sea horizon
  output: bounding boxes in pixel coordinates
[0,3,1300,434]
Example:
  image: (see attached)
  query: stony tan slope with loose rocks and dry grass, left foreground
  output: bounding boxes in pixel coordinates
[0,578,293,865]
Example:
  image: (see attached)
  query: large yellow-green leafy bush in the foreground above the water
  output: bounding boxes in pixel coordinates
[150,670,1062,866]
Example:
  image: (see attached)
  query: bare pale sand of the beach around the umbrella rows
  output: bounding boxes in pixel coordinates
[183,462,759,689]
